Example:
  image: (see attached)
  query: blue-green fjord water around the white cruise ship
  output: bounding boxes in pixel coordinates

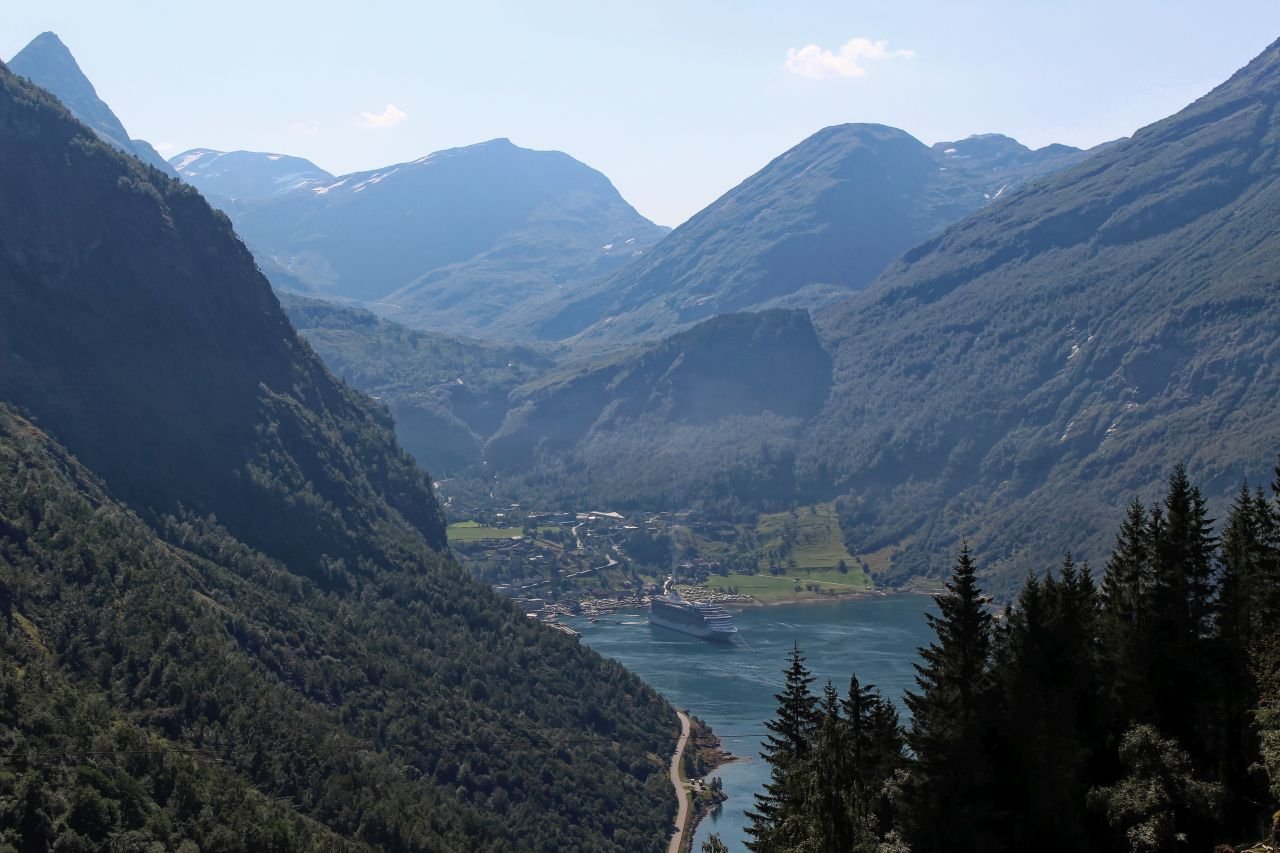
[573,596,933,850]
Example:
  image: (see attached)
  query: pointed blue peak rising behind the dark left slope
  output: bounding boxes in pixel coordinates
[9,32,174,175]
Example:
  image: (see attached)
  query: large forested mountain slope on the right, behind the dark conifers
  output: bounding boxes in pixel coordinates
[799,36,1280,589]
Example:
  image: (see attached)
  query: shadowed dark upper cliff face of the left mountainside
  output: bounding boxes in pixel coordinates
[0,59,444,560]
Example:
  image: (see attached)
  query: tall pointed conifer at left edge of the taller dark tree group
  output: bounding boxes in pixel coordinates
[902,543,998,853]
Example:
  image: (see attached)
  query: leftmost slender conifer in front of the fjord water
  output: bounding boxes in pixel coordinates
[746,644,818,853]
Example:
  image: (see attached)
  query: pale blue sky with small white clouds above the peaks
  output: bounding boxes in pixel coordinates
[0,0,1280,225]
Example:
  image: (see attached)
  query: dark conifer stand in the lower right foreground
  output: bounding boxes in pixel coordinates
[732,466,1280,853]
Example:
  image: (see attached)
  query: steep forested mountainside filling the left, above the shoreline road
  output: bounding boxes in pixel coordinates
[0,59,678,850]
